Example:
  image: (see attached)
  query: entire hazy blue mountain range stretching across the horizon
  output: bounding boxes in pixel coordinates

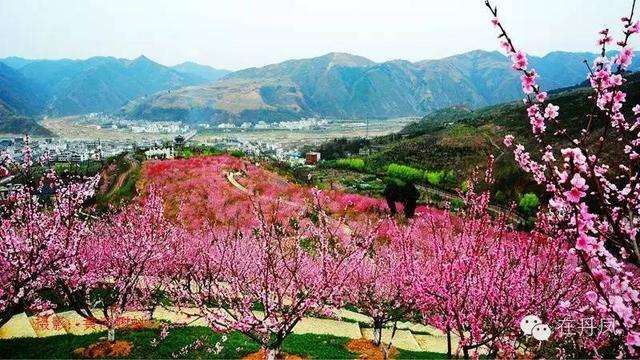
[0,51,637,133]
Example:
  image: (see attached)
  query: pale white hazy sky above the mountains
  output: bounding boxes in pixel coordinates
[0,0,631,70]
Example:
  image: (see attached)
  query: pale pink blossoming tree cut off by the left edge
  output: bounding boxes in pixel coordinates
[0,143,97,326]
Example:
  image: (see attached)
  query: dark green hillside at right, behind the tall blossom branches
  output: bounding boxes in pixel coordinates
[319,73,640,199]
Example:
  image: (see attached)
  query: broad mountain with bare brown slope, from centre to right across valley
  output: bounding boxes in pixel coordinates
[122,51,636,123]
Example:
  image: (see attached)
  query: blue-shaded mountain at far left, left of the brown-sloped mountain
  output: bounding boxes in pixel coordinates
[0,56,207,115]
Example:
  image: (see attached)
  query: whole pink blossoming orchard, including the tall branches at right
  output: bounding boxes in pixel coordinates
[0,1,640,359]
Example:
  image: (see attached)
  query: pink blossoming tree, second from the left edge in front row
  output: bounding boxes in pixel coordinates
[56,191,179,340]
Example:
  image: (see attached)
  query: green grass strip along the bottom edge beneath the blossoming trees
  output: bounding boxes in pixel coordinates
[0,327,355,359]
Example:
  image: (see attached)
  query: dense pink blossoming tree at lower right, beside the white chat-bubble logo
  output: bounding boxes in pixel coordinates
[405,166,583,358]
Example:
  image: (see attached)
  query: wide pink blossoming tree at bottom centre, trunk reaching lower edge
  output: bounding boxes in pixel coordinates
[168,202,372,359]
